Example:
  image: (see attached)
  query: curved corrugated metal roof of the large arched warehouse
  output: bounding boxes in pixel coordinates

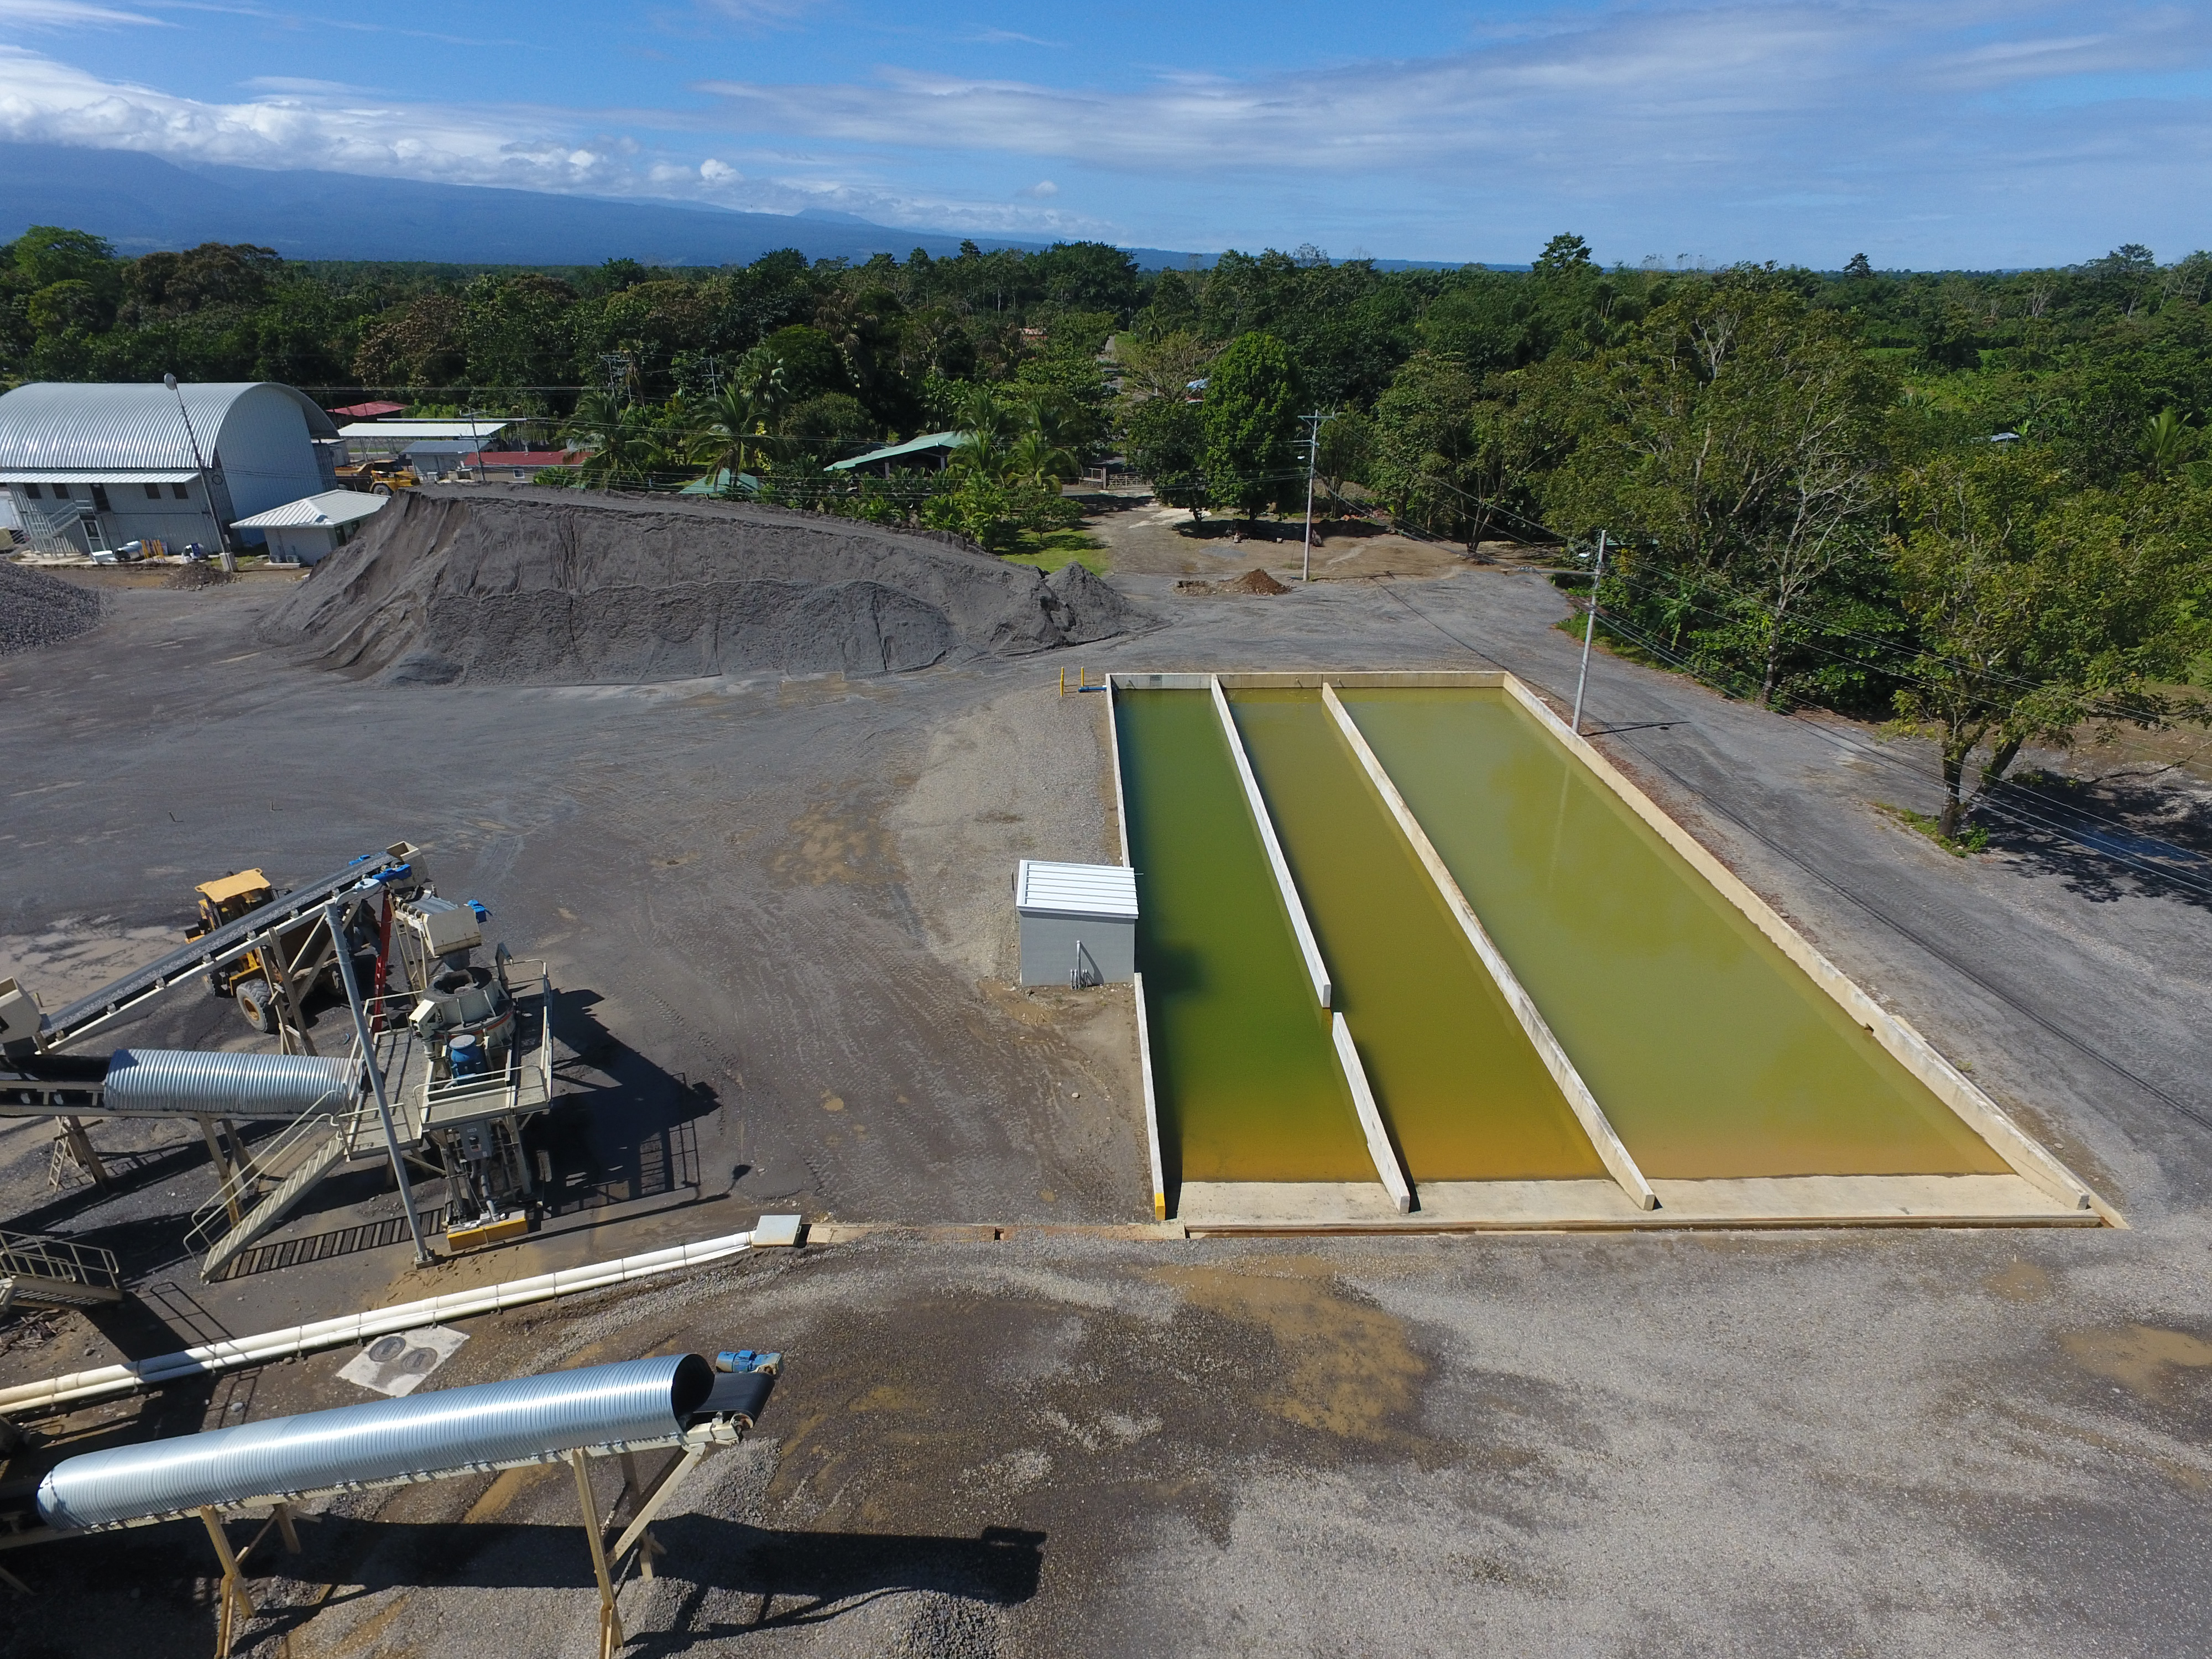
[0,380,338,478]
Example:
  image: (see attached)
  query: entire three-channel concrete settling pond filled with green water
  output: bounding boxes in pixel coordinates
[1113,675,2124,1230]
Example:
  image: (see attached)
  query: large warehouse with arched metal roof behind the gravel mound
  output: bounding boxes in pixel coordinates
[0,380,341,553]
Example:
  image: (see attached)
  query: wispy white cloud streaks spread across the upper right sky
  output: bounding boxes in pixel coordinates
[699,0,2212,175]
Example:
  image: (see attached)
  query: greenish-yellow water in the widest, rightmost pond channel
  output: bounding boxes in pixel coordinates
[1340,688,2008,1179]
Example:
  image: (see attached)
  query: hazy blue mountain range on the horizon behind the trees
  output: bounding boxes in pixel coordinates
[0,144,1486,270]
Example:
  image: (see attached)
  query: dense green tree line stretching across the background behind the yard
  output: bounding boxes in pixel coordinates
[0,228,2212,832]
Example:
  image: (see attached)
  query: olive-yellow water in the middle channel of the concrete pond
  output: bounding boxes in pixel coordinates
[1230,690,1606,1181]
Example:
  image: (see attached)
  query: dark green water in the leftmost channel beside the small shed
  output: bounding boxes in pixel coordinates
[1115,690,1376,1186]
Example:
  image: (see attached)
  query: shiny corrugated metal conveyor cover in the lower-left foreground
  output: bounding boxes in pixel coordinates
[38,1354,714,1531]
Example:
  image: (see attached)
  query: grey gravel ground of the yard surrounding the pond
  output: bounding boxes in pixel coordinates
[0,571,2212,1659]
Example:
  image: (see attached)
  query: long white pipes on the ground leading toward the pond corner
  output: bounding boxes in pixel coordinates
[0,1232,752,1413]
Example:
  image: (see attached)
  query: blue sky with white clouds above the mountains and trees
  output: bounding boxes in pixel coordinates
[0,0,2212,268]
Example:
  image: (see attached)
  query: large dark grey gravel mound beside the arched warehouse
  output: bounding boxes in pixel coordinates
[265,484,1150,684]
